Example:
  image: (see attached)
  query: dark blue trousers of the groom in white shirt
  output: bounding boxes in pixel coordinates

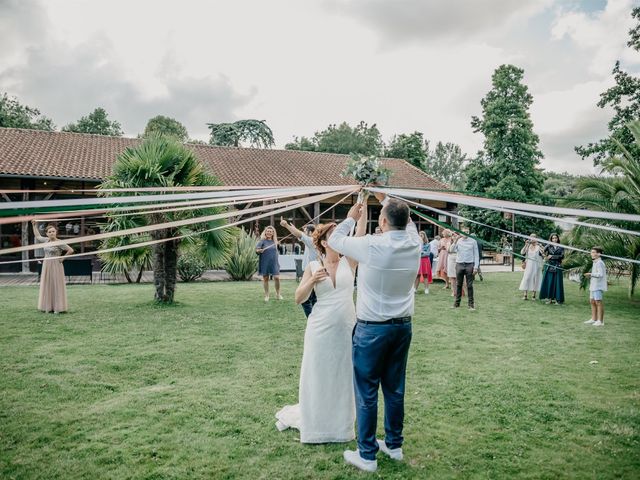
[352,322,411,460]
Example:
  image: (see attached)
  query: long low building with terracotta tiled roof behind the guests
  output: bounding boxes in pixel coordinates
[0,128,453,270]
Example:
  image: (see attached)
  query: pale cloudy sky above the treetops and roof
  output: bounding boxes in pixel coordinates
[0,0,640,174]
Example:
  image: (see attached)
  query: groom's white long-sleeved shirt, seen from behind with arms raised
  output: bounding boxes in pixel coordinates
[329,218,422,322]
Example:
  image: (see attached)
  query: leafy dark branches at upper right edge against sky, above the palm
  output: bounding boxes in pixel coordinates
[575,7,640,165]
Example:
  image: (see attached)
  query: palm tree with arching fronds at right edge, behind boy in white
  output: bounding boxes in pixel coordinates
[563,121,640,296]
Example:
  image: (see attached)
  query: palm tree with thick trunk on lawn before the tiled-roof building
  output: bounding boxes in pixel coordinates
[101,136,233,303]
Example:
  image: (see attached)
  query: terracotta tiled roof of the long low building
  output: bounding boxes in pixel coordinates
[0,128,447,189]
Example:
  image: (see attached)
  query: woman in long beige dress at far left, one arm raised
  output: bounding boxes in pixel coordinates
[31,220,73,313]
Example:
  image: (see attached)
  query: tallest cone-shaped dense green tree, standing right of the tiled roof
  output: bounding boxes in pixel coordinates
[465,65,553,240]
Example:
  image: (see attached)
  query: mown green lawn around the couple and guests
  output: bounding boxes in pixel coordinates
[0,273,640,479]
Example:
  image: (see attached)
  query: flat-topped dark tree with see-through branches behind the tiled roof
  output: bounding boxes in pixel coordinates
[207,120,275,148]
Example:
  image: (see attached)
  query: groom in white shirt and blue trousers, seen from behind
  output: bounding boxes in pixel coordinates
[329,193,422,472]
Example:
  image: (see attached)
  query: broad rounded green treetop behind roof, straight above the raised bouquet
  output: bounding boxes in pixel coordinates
[285,122,384,155]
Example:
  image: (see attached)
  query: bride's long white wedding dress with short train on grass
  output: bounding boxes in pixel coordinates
[276,257,356,443]
